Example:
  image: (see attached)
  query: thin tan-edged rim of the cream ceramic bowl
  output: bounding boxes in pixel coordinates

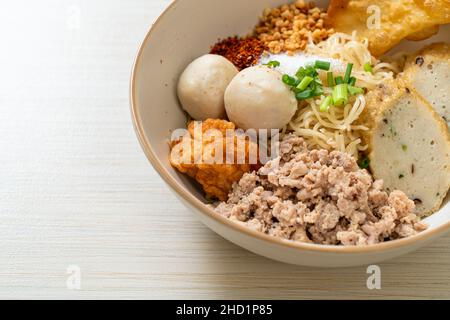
[129,0,450,254]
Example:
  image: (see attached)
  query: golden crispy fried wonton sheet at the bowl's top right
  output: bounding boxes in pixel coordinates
[327,0,450,57]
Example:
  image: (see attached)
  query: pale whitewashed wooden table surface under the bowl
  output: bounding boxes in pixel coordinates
[0,0,450,299]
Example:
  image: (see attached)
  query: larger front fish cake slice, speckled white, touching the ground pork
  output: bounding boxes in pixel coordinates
[365,80,450,216]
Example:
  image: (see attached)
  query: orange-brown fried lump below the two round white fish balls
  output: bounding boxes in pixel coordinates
[170,119,257,201]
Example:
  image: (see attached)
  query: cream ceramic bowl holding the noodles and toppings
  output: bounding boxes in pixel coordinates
[131,0,450,267]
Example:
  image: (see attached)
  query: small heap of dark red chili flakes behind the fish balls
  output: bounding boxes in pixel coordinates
[211,37,267,70]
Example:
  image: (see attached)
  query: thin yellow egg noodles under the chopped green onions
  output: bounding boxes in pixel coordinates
[287,32,400,158]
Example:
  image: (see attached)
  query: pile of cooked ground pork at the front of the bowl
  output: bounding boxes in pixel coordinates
[214,135,427,246]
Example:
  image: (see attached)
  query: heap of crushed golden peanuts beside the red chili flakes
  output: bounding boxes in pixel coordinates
[254,0,334,55]
